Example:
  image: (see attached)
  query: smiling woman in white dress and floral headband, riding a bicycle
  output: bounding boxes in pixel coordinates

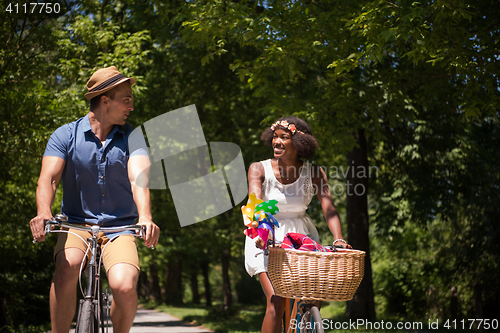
[245,117,351,333]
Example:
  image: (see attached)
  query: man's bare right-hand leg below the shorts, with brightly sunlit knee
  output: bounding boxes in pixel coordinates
[108,263,139,333]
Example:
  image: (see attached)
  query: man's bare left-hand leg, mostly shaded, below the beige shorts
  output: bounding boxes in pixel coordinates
[50,248,84,333]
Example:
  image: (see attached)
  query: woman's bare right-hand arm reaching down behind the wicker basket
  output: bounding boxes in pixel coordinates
[312,166,352,248]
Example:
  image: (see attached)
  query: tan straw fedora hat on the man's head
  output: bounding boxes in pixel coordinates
[85,66,135,101]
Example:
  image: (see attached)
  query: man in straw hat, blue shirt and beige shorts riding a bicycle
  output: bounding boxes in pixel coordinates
[30,66,160,333]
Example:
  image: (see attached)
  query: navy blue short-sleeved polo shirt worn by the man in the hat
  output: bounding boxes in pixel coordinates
[43,115,148,236]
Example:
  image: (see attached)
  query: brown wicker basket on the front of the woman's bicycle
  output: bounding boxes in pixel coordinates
[267,247,365,301]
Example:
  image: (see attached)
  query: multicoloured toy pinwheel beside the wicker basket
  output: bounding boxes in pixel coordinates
[241,193,279,240]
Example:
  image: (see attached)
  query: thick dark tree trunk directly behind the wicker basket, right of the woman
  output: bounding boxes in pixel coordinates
[345,129,375,321]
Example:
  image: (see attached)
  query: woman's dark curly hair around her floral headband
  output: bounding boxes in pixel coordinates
[260,116,318,159]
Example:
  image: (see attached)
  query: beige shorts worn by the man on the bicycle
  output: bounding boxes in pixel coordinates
[54,224,140,272]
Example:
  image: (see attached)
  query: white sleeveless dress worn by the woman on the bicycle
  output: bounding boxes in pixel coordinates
[245,159,319,276]
